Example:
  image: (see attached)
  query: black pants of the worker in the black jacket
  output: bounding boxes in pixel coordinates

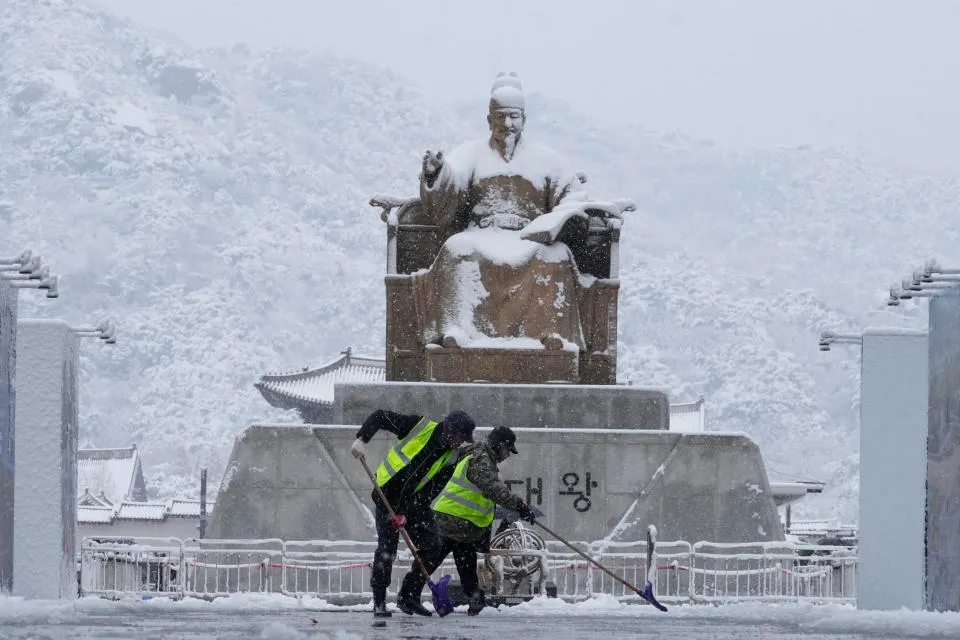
[370,500,440,602]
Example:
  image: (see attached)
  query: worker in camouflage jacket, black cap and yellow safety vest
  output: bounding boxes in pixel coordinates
[399,426,543,615]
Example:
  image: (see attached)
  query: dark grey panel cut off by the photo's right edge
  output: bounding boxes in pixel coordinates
[925,287,960,611]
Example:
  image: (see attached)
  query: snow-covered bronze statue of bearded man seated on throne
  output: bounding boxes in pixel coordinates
[371,73,633,384]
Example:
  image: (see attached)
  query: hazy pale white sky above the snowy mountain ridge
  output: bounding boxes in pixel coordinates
[97,0,960,171]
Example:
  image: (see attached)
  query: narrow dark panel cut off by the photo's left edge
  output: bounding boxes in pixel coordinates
[0,278,17,592]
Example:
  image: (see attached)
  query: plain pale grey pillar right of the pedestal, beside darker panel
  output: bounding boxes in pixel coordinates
[857,329,928,611]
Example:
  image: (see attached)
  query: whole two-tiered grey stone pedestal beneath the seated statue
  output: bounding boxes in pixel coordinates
[209,382,783,542]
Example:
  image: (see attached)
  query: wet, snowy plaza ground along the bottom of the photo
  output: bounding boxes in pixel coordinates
[0,595,960,640]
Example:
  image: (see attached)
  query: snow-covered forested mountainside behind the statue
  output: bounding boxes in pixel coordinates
[0,0,960,520]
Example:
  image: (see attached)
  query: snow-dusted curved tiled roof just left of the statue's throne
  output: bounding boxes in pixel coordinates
[254,349,387,409]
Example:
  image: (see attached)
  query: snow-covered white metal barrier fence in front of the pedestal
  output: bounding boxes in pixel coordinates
[79,537,857,604]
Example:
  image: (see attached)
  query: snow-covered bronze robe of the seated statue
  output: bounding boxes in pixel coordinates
[412,138,592,350]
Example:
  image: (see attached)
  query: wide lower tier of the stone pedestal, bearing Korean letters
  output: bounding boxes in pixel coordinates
[208,425,783,544]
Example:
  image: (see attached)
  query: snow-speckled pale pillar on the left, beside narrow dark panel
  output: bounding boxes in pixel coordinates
[13,320,79,599]
